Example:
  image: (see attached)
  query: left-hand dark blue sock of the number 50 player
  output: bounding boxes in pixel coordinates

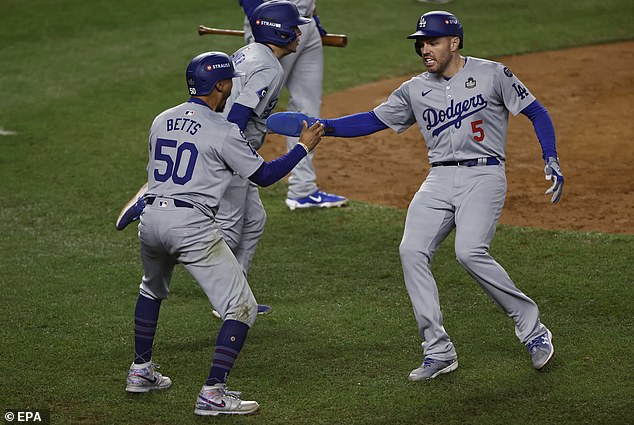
[134,294,161,364]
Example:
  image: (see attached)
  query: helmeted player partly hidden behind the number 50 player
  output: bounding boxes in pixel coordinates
[116,0,310,316]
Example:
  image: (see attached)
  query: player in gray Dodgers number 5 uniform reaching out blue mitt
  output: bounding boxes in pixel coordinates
[267,11,564,381]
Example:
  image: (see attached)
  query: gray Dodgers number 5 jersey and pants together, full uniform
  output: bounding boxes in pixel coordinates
[374,58,545,360]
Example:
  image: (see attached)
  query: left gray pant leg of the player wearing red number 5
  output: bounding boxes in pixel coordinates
[399,170,456,360]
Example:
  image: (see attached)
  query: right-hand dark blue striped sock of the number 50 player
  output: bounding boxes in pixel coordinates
[205,319,249,385]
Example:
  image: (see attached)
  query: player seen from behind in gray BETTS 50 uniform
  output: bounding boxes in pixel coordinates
[126,52,323,416]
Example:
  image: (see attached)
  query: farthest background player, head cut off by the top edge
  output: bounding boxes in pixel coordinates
[238,0,348,210]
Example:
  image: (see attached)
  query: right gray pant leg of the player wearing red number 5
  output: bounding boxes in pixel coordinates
[455,165,544,343]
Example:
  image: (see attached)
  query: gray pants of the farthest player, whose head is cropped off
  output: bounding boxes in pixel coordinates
[280,21,324,199]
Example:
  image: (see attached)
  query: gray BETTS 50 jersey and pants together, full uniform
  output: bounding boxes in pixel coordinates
[139,99,264,326]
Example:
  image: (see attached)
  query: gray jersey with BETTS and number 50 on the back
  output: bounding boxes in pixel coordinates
[146,98,264,217]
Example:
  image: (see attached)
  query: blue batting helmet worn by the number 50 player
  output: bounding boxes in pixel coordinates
[185,52,244,96]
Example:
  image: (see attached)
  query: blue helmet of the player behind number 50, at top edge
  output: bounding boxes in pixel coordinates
[249,0,310,46]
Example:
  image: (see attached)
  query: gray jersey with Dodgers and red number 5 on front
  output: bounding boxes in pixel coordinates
[374,57,535,163]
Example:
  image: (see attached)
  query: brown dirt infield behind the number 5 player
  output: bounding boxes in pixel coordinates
[262,41,634,234]
